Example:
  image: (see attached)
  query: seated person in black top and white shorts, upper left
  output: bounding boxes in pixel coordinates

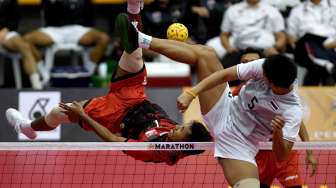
[24,0,109,66]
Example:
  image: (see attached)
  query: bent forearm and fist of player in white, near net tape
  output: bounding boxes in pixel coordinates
[271,116,294,161]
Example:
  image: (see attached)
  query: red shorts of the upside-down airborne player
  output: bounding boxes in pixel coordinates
[82,67,147,133]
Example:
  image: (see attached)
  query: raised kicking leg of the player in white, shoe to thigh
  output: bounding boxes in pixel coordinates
[115,14,226,114]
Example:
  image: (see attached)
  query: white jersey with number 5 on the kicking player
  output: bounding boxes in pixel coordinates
[230,59,303,142]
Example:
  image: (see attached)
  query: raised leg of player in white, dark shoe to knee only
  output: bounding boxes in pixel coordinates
[115,14,222,72]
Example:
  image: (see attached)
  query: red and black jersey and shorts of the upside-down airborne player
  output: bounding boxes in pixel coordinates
[82,67,186,165]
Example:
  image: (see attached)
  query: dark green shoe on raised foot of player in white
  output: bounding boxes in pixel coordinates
[115,13,139,54]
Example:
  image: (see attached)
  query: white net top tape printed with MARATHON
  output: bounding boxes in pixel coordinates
[0,142,336,151]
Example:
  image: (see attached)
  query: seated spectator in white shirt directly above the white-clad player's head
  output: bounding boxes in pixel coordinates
[208,0,286,67]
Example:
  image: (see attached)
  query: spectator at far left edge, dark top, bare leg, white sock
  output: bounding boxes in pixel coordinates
[0,0,42,89]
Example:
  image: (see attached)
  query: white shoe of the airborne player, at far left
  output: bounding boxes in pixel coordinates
[6,108,37,140]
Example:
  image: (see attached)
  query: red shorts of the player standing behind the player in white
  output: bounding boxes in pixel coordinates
[256,150,303,187]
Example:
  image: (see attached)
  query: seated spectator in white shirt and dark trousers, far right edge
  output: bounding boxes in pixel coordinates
[287,0,336,85]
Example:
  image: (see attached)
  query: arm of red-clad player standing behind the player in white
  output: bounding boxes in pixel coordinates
[299,122,318,176]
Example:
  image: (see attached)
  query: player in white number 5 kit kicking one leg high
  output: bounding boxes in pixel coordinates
[116,15,302,188]
